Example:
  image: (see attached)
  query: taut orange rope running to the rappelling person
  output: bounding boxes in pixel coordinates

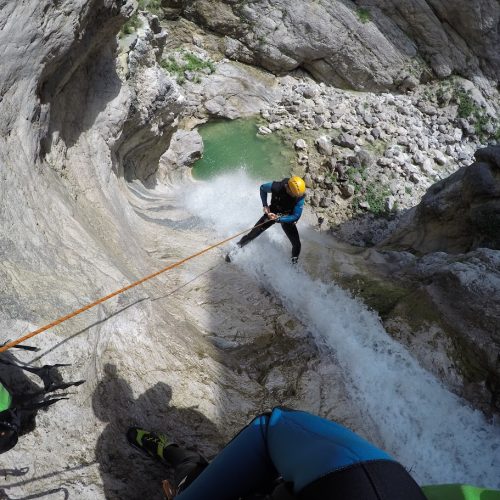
[0,221,268,352]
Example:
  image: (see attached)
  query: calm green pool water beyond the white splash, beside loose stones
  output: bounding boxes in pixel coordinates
[192,119,294,180]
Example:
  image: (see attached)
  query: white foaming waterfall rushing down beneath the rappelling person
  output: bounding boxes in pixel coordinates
[183,173,500,488]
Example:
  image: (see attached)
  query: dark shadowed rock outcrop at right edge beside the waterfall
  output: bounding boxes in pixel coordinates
[379,146,500,411]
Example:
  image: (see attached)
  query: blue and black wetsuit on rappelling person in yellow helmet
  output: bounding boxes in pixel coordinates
[238,179,305,257]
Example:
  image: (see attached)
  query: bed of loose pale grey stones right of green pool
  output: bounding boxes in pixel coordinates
[259,73,492,227]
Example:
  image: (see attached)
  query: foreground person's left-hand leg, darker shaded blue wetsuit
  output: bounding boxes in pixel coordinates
[175,415,279,500]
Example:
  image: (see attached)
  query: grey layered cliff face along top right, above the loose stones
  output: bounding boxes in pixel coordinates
[173,0,500,90]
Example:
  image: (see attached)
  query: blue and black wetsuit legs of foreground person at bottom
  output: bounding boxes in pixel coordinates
[169,408,425,500]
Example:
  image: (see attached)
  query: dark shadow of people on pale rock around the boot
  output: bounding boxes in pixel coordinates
[92,364,222,500]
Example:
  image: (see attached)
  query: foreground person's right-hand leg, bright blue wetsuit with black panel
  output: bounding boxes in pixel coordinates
[267,408,425,500]
